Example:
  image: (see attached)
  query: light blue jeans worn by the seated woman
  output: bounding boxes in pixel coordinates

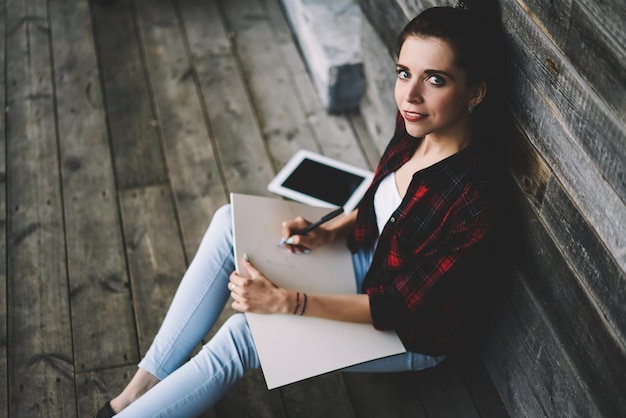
[116,205,443,418]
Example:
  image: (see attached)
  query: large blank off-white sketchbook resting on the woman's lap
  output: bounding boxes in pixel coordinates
[231,193,406,389]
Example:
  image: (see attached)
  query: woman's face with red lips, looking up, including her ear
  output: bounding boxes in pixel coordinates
[395,36,486,140]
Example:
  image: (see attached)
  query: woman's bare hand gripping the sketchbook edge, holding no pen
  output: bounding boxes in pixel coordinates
[228,258,288,314]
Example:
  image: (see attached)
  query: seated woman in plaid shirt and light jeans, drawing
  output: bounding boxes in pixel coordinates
[97,4,508,418]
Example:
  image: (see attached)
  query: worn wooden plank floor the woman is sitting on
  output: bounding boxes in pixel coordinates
[0,0,506,418]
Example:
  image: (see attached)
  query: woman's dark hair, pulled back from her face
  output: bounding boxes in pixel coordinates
[398,0,511,159]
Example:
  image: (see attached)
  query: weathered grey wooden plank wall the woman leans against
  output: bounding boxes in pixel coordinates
[360,0,626,417]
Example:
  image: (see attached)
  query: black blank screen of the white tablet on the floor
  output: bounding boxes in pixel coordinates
[282,158,365,206]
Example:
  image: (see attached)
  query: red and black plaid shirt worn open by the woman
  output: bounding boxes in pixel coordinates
[349,117,494,355]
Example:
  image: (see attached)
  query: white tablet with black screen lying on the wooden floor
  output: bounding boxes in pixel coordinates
[267,150,374,214]
